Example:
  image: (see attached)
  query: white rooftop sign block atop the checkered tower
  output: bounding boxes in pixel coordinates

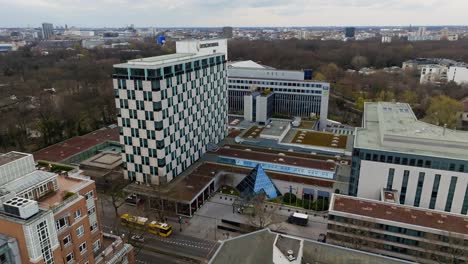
[176,39,228,60]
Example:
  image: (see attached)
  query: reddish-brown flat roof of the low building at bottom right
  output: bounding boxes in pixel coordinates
[330,194,468,235]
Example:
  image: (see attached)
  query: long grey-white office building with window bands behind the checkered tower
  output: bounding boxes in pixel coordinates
[228,61,330,126]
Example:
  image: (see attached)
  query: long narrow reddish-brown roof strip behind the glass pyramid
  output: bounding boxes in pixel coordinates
[211,147,336,172]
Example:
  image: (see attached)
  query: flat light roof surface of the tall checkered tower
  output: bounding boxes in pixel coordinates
[114,53,224,69]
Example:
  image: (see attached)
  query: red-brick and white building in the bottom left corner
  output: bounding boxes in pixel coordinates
[0,152,133,264]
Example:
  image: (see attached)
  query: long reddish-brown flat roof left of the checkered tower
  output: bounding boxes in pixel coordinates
[33,127,120,162]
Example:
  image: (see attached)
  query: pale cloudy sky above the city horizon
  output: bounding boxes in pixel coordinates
[0,0,468,27]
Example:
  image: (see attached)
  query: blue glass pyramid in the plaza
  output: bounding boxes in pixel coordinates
[236,164,281,199]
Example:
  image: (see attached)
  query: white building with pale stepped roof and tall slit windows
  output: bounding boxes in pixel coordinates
[349,102,468,214]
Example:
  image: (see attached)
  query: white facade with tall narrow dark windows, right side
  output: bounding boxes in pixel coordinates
[357,160,468,214]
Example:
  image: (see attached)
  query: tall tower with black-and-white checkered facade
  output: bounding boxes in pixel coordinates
[113,53,228,184]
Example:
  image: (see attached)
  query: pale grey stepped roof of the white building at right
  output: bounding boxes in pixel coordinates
[354,102,468,160]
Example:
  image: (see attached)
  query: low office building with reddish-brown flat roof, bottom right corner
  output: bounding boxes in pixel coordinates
[327,194,468,263]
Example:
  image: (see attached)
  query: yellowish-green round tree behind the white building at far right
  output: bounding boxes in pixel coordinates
[426,95,463,128]
